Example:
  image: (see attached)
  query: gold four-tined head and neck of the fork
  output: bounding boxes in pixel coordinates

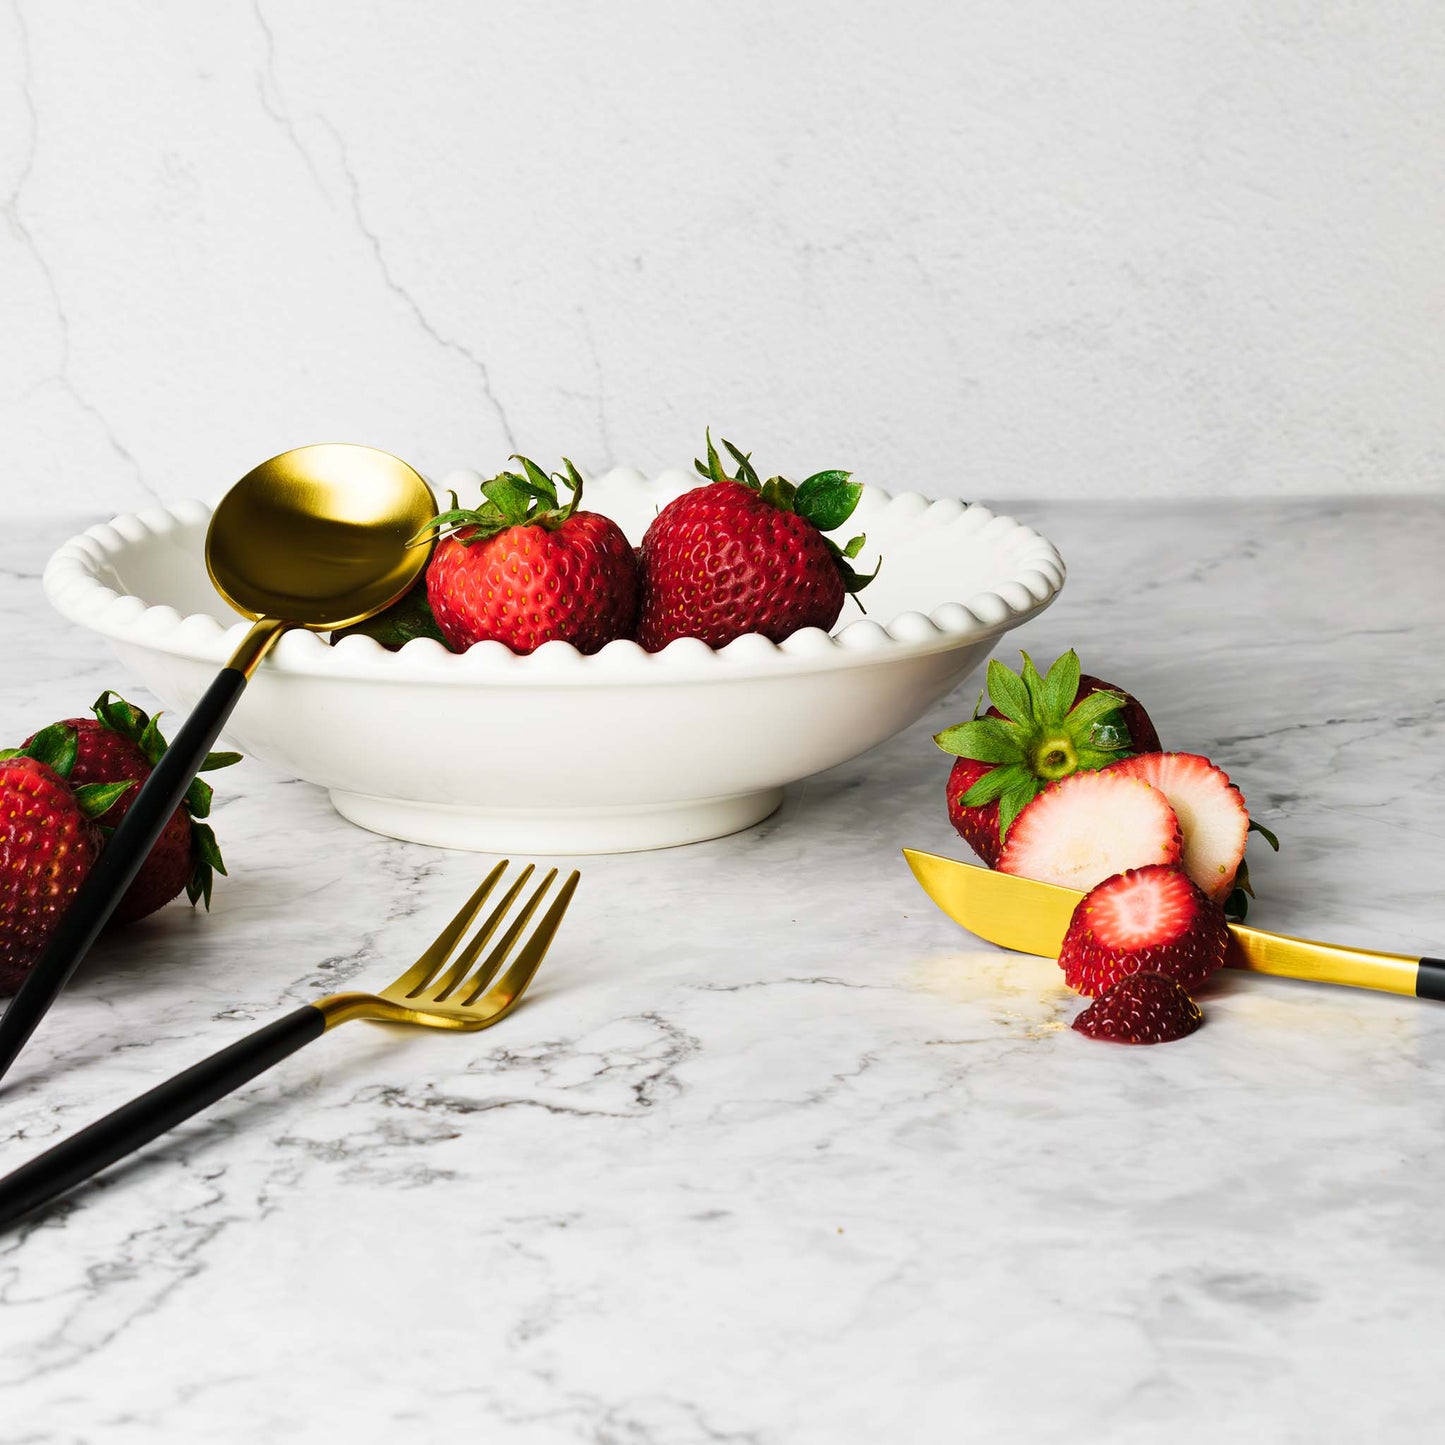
[314,860,581,1032]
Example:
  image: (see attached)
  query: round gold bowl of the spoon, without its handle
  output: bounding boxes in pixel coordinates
[205,442,436,631]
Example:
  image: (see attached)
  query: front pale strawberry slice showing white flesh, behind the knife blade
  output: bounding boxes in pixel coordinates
[998,769,1183,890]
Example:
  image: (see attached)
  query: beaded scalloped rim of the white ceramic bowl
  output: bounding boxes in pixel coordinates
[42,468,1066,686]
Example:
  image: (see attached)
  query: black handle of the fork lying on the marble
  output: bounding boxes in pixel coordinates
[0,1003,327,1230]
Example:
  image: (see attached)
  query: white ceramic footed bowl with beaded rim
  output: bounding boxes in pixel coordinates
[45,468,1064,853]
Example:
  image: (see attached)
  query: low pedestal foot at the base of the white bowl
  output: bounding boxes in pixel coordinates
[331,788,783,855]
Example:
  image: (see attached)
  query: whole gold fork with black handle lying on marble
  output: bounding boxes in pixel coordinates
[0,860,578,1230]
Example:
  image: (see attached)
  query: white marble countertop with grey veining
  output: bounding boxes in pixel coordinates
[0,499,1445,1445]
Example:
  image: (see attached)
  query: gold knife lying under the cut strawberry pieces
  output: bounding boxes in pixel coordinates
[903,848,1445,1000]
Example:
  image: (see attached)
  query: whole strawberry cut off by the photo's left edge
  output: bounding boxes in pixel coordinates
[0,725,134,994]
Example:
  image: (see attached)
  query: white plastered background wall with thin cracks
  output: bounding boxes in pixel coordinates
[0,0,1445,514]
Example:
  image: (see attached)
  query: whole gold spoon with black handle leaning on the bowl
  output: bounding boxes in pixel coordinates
[0,444,436,1077]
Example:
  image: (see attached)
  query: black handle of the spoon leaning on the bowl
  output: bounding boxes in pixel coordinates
[0,668,246,1078]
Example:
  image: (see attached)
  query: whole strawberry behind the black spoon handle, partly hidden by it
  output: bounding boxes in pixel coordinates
[26,689,241,928]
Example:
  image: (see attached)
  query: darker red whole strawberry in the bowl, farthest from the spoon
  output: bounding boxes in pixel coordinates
[637,432,877,652]
